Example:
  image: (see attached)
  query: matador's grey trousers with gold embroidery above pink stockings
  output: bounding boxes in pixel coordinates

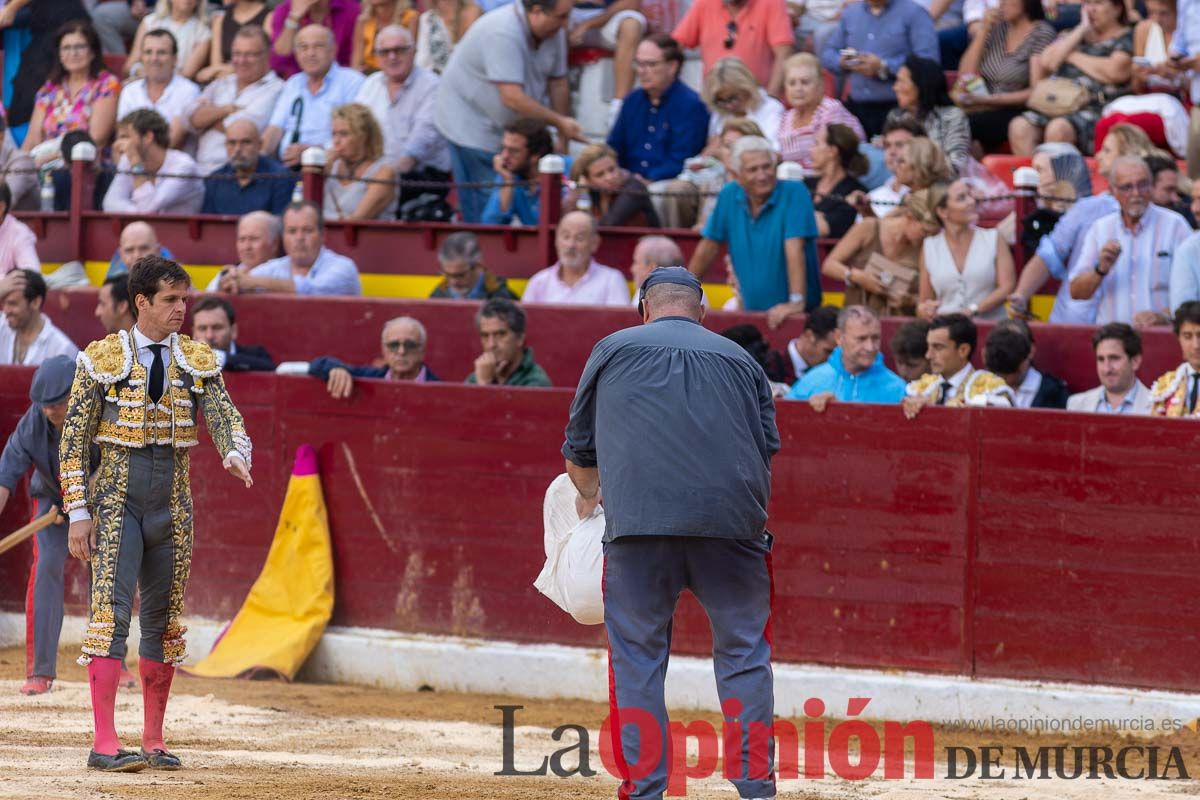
[108,445,175,661]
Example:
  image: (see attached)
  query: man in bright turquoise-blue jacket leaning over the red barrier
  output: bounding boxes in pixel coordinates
[787,306,905,413]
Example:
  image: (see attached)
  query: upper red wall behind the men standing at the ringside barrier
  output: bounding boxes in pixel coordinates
[47,289,1181,391]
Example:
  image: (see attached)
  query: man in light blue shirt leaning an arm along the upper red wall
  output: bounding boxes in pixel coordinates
[229,200,362,295]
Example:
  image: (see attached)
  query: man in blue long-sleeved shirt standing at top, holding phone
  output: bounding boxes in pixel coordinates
[820,0,941,137]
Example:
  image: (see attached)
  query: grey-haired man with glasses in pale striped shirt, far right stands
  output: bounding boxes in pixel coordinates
[1070,156,1192,327]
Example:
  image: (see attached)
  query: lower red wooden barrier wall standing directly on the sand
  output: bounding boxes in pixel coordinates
[0,367,1200,690]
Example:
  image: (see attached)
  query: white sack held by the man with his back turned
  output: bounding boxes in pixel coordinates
[533,473,604,625]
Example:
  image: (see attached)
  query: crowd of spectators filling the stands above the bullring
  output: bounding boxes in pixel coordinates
[0,0,1200,415]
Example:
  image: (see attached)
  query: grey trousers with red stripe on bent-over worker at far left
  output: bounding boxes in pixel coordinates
[25,498,67,678]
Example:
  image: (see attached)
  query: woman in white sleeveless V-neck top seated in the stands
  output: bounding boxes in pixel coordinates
[917,180,1016,320]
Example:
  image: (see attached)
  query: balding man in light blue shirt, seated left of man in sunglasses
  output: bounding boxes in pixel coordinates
[263,25,365,167]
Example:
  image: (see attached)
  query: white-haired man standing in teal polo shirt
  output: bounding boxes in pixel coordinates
[688,136,821,327]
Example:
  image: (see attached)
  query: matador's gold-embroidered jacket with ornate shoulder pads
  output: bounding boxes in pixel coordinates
[59,331,251,512]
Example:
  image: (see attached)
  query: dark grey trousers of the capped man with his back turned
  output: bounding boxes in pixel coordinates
[604,534,775,800]
